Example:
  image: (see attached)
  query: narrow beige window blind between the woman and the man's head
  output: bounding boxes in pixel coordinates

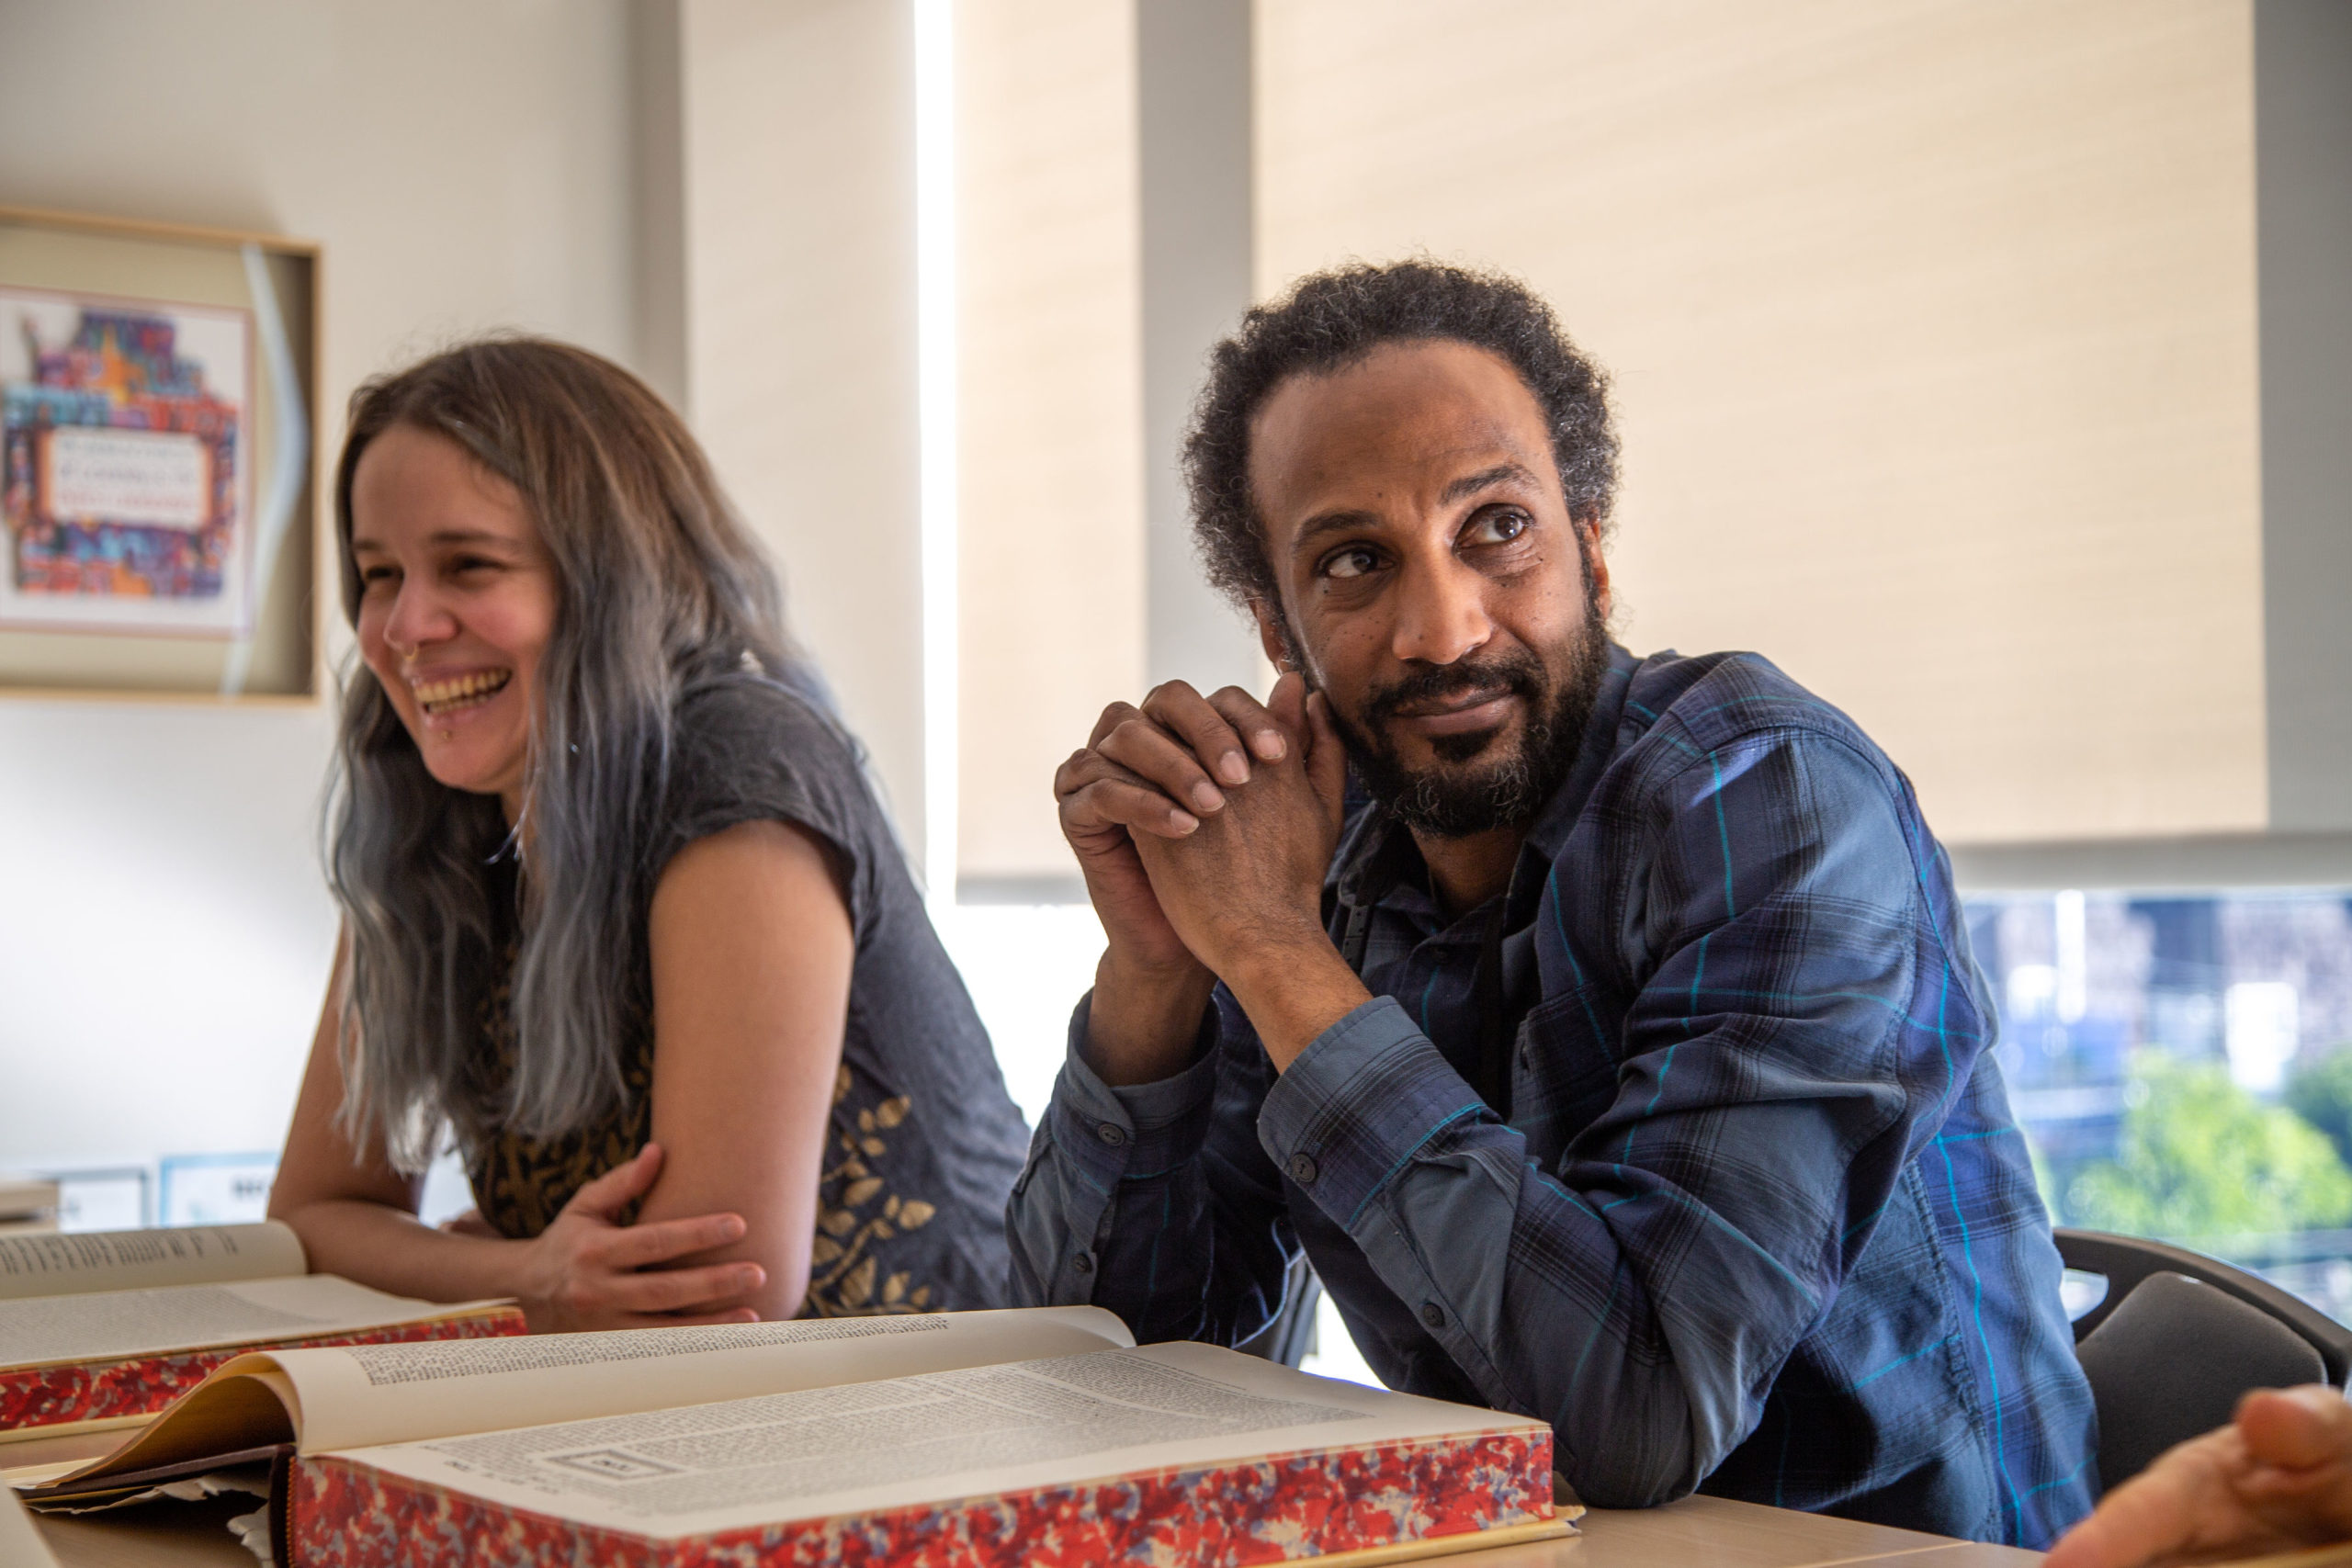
[955,0,1143,877]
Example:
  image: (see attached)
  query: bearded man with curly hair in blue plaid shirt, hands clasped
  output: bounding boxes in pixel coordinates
[1009,261,2096,1547]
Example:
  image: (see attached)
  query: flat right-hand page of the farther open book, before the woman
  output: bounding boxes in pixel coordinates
[0,1274,492,1366]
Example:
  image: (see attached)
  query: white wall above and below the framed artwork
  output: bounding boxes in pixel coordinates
[0,0,635,1168]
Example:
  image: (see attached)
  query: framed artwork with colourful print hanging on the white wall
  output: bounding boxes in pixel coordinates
[0,207,320,701]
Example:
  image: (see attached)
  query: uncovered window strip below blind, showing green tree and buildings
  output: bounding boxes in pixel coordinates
[1966,891,2352,1321]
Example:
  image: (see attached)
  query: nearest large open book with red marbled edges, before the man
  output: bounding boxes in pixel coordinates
[26,1307,1569,1568]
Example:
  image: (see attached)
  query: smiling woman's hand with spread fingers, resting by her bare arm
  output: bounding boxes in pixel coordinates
[517,1143,767,1333]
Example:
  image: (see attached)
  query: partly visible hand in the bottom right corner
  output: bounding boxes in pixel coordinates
[2046,1384,2352,1568]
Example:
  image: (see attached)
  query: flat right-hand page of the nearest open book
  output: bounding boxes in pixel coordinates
[344,1345,1543,1540]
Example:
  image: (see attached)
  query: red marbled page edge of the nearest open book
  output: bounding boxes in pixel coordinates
[289,1429,1553,1568]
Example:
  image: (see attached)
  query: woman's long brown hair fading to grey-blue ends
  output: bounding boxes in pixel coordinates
[327,339,793,1170]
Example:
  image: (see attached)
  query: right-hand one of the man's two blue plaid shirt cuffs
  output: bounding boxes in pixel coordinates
[1259,997,1487,1232]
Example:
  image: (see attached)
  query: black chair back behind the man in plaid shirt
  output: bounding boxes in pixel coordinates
[2058,1229,2352,1488]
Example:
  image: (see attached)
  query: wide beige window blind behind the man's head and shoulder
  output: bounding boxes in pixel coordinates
[1259,0,2267,841]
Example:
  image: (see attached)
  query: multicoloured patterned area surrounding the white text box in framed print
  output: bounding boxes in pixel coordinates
[0,306,243,600]
